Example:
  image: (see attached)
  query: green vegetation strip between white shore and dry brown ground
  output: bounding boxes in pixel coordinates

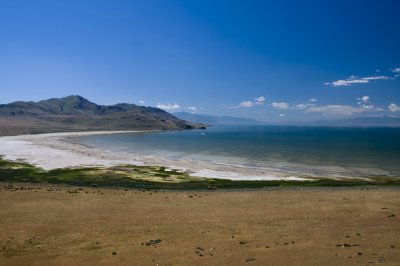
[0,156,400,190]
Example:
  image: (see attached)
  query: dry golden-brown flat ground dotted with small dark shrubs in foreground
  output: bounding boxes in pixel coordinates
[0,183,400,266]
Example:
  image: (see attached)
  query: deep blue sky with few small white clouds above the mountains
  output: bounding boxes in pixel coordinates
[0,0,400,121]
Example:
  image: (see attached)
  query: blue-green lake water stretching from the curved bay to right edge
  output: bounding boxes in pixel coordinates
[73,126,400,177]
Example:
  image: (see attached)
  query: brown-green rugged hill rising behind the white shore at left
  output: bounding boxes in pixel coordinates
[0,95,204,135]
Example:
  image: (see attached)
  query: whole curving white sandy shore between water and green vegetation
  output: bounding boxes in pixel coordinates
[0,131,307,180]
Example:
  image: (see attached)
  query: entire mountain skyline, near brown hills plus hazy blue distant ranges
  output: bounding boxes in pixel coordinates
[0,95,400,135]
